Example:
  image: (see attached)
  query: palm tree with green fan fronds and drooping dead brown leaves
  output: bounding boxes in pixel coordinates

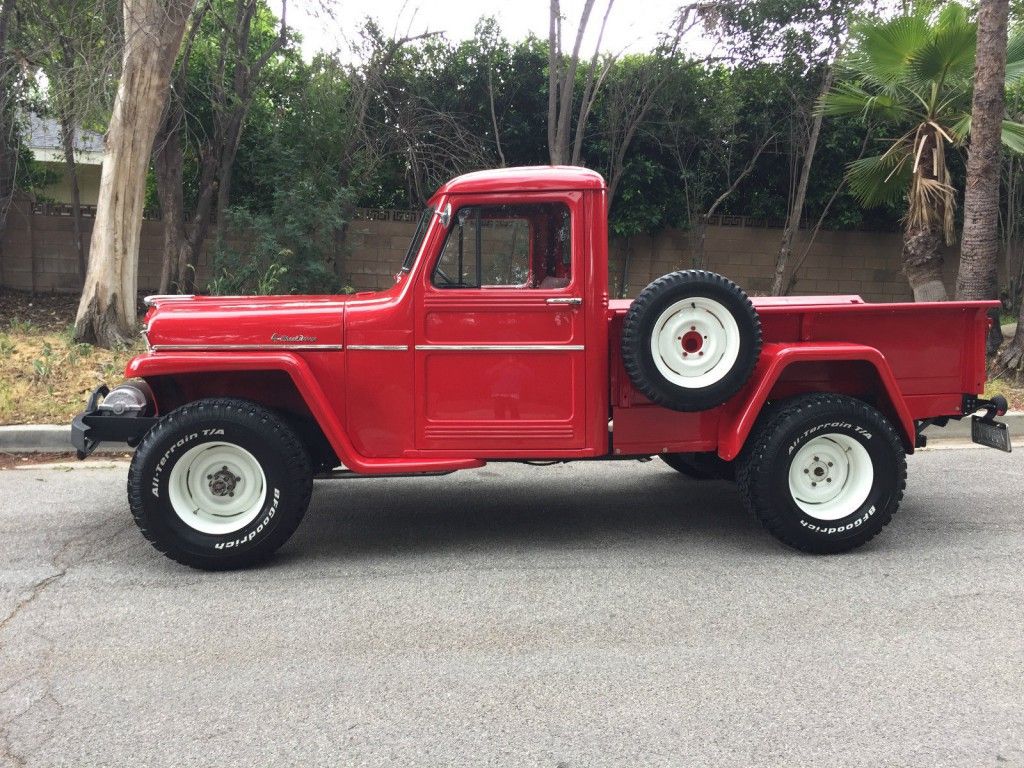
[821,3,1024,301]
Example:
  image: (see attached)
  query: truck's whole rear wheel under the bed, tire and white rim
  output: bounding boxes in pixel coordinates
[736,394,906,554]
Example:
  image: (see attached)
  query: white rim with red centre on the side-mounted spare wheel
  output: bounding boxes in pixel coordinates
[650,296,739,389]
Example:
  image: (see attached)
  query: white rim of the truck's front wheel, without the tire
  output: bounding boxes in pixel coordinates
[168,442,266,536]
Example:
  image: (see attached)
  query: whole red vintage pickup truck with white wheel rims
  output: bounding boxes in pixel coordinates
[73,168,1010,568]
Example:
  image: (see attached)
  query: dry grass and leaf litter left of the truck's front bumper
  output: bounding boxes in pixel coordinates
[0,292,144,425]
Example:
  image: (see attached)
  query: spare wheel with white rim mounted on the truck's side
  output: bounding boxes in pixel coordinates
[623,269,761,411]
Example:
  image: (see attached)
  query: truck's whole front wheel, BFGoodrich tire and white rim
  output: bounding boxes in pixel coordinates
[128,398,312,570]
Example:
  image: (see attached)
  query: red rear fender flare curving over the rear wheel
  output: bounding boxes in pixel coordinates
[718,342,914,461]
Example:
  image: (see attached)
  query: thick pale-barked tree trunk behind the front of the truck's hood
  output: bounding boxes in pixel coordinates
[75,0,195,347]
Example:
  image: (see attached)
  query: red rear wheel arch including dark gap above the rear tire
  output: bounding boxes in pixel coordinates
[718,342,914,461]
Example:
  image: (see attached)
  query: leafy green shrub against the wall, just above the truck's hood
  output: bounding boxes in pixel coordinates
[208,181,347,295]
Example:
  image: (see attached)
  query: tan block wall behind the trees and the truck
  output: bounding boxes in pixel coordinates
[0,201,956,301]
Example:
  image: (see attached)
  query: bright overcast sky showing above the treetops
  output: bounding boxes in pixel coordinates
[286,0,703,58]
